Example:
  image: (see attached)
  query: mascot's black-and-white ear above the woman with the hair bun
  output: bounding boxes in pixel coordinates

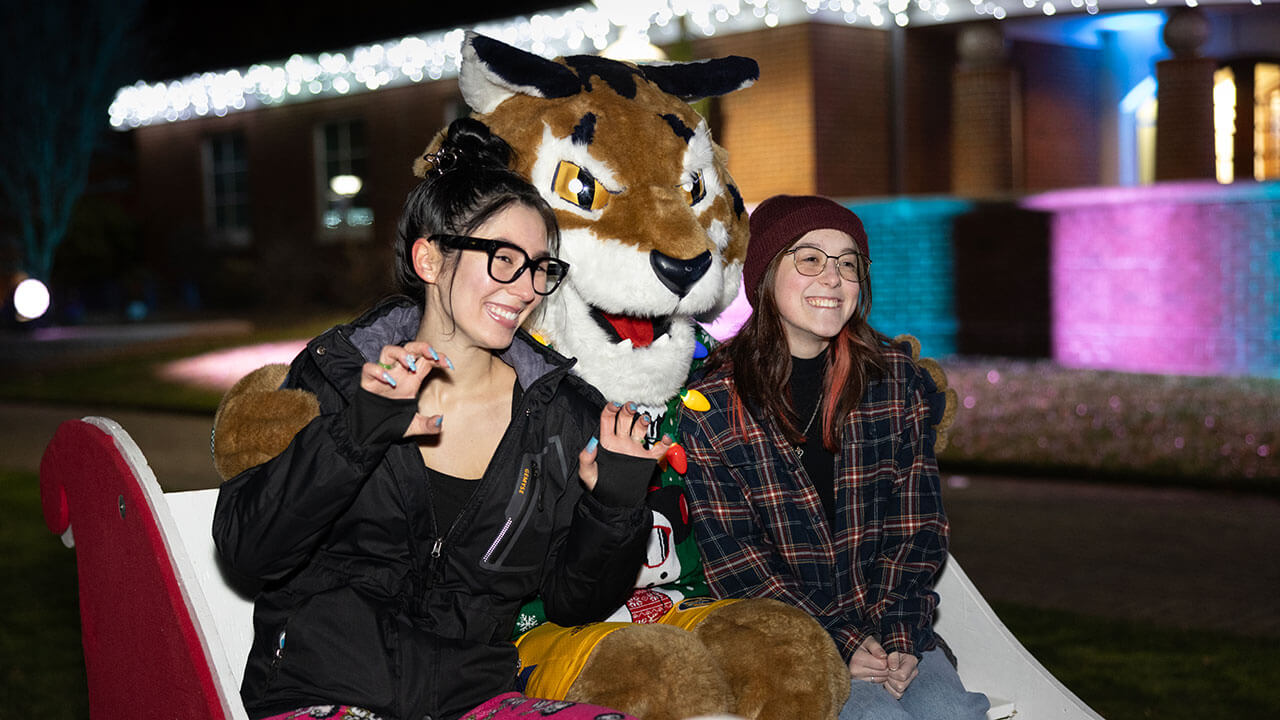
[458,32,582,115]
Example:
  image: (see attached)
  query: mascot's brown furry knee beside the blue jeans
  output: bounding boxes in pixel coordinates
[694,600,849,720]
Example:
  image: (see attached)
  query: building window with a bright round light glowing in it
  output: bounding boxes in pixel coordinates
[316,120,374,240]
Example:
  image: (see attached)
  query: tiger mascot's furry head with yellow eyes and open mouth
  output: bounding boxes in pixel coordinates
[415,33,759,407]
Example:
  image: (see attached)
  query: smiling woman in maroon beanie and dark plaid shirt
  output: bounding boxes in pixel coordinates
[681,195,988,720]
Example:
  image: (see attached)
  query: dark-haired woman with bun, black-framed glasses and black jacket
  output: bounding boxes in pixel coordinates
[214,119,669,720]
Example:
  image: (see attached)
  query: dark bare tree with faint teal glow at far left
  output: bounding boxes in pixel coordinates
[0,0,141,282]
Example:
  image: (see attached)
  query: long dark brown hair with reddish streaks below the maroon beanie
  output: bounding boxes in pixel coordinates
[707,243,888,452]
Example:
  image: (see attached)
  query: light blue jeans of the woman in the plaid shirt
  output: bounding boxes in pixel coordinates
[840,648,991,720]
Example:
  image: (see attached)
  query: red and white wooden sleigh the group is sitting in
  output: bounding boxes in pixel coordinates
[40,418,1101,720]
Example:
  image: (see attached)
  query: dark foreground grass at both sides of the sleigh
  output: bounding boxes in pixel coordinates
[0,471,1280,720]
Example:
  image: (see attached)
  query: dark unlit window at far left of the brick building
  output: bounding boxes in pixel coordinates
[204,132,251,247]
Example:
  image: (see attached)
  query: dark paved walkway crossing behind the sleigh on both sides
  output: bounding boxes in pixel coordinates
[0,404,1280,637]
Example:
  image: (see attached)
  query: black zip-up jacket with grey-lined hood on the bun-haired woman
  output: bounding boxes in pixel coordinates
[214,300,652,720]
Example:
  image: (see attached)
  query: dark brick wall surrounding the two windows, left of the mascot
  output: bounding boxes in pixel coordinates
[133,81,457,307]
